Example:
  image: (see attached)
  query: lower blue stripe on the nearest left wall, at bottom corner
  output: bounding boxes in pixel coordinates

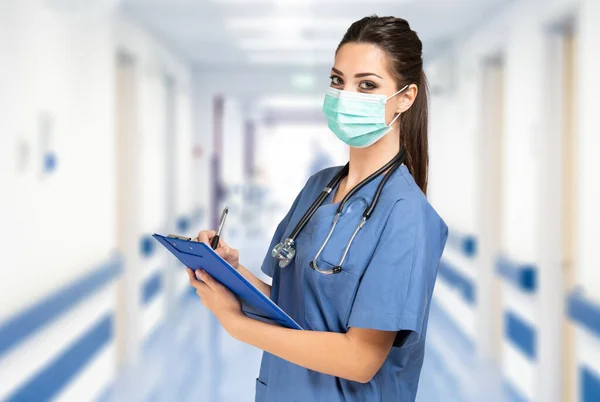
[6,314,113,402]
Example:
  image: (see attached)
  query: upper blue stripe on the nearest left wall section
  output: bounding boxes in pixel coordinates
[0,255,122,356]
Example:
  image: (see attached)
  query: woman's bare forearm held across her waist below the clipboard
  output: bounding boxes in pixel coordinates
[230,317,391,383]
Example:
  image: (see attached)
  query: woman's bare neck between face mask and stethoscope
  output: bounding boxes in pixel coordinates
[345,133,400,188]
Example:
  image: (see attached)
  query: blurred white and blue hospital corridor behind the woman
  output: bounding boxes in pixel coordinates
[0,0,600,402]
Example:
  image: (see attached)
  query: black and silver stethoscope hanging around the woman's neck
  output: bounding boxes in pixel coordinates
[271,148,406,275]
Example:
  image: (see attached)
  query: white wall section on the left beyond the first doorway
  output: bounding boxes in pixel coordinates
[113,19,195,235]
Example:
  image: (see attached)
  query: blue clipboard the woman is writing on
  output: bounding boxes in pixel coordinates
[152,233,302,329]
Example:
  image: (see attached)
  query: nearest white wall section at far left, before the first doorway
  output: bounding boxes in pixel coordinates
[0,0,115,320]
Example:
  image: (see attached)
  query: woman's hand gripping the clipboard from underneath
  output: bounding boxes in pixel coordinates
[186,268,245,333]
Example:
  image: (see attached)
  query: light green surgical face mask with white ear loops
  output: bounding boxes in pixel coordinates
[323,85,408,148]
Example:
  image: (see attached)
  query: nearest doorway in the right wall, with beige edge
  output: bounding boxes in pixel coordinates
[539,18,577,402]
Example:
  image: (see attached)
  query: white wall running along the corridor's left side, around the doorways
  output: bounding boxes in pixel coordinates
[0,0,197,392]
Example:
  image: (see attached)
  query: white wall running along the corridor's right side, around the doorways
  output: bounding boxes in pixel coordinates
[431,0,600,401]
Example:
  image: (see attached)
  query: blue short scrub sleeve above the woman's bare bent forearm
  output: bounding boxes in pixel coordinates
[348,199,441,346]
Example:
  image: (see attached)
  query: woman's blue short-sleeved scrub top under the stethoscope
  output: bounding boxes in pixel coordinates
[256,165,448,402]
